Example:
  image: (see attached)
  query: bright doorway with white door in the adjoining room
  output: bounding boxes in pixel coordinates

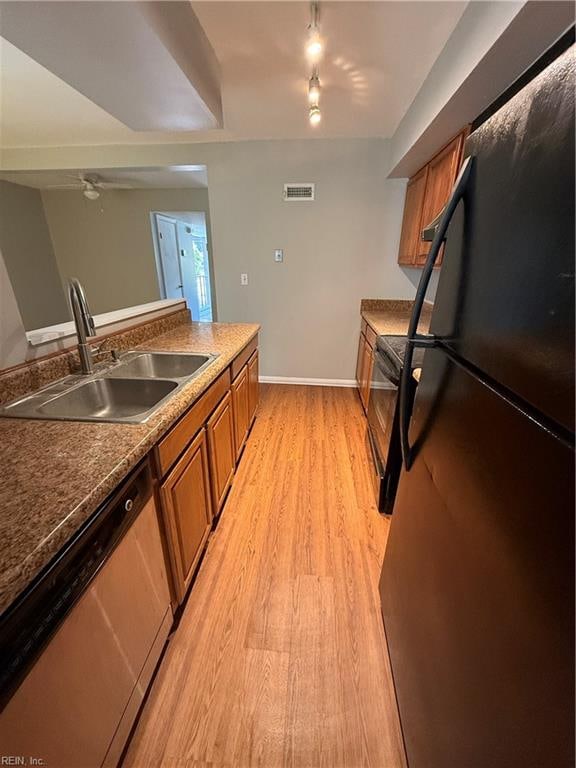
[151,211,213,323]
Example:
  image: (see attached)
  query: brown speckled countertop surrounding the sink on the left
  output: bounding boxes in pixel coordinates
[0,322,260,612]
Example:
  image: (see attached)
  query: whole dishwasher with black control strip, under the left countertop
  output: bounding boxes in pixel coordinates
[0,462,172,768]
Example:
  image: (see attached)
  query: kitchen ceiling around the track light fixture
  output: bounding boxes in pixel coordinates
[0,1,466,147]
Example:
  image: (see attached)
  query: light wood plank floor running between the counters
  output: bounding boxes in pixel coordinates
[123,385,405,768]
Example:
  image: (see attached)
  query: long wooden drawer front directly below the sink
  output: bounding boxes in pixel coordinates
[156,368,230,477]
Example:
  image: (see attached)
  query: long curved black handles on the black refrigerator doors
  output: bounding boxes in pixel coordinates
[399,155,474,471]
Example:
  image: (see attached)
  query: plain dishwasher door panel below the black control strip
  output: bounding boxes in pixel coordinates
[0,499,170,768]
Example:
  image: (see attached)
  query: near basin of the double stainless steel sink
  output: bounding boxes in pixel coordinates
[37,379,178,420]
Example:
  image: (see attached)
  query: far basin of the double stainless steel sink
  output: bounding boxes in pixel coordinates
[104,352,214,379]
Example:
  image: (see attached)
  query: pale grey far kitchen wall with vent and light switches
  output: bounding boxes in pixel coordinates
[0,139,419,380]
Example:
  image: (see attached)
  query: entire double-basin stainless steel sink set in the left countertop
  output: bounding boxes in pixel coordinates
[0,350,217,424]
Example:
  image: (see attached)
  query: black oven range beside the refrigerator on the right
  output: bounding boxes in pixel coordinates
[368,336,422,514]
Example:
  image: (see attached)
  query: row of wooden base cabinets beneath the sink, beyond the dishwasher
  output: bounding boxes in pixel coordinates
[155,336,258,603]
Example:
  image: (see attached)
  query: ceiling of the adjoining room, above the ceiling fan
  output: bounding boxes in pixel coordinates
[0,165,208,189]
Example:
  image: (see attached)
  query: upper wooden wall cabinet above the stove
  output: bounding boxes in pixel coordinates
[398,127,468,267]
